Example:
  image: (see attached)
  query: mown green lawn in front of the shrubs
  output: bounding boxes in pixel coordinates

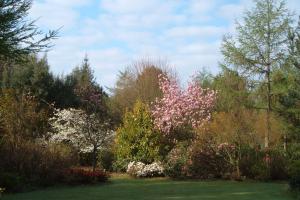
[1,176,292,200]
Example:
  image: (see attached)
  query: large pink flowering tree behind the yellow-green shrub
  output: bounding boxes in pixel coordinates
[152,75,216,135]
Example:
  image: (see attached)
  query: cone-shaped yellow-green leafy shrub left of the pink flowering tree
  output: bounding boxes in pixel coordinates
[115,101,161,164]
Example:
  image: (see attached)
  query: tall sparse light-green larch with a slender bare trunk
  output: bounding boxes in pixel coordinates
[222,0,291,147]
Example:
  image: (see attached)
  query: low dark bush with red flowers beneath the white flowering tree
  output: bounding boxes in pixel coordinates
[64,168,109,185]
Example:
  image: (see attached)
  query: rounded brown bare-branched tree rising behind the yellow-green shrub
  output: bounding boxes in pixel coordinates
[112,59,175,121]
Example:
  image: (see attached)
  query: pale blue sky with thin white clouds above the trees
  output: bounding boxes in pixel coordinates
[30,0,300,87]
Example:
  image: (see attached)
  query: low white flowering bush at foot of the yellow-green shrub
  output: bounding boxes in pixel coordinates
[126,161,164,177]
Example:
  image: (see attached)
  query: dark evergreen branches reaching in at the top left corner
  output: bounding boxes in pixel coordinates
[0,0,57,61]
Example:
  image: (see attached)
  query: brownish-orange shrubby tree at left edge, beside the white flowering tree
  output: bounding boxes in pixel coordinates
[0,89,49,141]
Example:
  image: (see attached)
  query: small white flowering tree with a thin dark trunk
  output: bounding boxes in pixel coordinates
[50,108,114,170]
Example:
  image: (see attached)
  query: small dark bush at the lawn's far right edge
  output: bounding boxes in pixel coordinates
[289,160,300,192]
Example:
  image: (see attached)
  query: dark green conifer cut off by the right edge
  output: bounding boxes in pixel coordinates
[272,20,300,142]
